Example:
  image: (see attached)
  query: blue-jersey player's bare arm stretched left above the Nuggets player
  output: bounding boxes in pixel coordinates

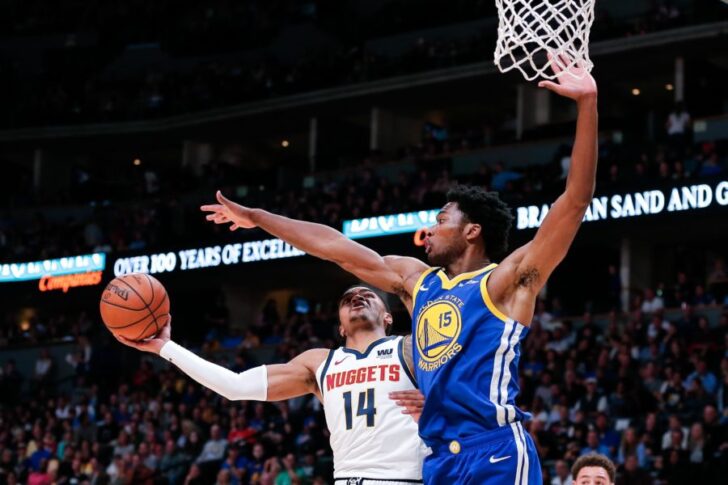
[201,191,427,308]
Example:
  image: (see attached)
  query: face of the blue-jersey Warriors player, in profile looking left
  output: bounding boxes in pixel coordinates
[425,202,467,266]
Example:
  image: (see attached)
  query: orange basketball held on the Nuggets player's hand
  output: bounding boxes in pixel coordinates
[100,273,169,340]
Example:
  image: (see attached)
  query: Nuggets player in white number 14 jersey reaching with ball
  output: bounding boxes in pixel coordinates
[117,287,428,485]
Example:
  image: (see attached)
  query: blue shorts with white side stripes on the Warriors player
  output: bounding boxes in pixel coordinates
[422,422,543,485]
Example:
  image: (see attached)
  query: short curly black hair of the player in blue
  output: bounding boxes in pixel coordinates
[447,185,513,260]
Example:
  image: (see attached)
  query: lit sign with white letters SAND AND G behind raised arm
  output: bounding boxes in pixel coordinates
[516,180,728,229]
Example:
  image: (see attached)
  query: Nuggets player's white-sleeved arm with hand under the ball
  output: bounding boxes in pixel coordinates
[115,323,329,401]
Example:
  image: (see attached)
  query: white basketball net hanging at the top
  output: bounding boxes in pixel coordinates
[494,0,595,81]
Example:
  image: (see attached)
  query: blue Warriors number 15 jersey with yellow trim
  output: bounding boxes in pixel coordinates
[412,264,529,448]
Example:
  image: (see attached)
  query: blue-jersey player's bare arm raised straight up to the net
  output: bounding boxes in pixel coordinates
[487,60,598,323]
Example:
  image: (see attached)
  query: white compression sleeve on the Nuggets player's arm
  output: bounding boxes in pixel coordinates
[159,340,268,401]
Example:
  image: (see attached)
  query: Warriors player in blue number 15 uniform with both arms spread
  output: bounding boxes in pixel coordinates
[202,60,597,484]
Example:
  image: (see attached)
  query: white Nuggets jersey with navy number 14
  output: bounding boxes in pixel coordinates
[316,336,427,483]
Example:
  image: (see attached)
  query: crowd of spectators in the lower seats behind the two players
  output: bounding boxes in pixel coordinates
[0,264,728,485]
